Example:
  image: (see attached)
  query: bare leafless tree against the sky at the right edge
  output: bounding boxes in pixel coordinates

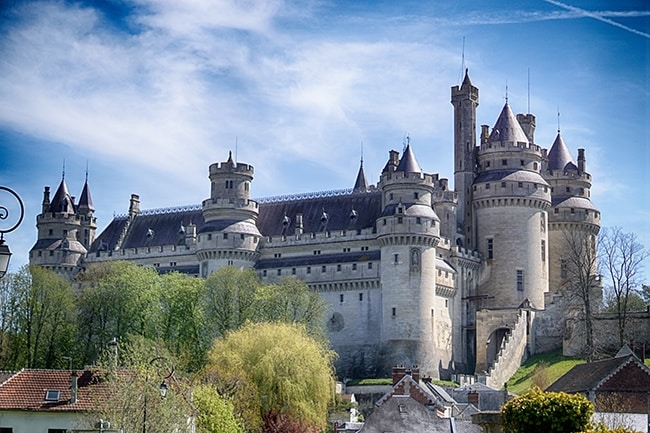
[599,227,650,347]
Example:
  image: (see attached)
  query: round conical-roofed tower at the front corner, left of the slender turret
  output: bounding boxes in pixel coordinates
[377,145,440,376]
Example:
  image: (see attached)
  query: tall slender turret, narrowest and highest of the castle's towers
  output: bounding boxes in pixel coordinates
[451,70,478,248]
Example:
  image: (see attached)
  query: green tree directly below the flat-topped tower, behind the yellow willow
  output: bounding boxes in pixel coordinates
[205,266,260,338]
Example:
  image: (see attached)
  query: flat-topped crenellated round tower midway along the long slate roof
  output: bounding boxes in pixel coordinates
[196,153,262,277]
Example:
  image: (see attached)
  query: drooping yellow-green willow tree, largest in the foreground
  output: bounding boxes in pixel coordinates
[208,323,334,431]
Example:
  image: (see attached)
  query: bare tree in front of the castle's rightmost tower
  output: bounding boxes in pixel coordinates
[563,226,601,362]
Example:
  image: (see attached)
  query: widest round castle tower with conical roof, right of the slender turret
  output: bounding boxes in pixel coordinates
[472,103,551,309]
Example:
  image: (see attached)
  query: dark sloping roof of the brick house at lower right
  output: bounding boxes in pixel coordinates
[546,354,650,393]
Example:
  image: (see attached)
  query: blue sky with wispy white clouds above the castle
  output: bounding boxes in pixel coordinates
[0,0,650,271]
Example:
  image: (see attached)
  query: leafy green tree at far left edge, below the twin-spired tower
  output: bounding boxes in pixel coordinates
[1,266,75,369]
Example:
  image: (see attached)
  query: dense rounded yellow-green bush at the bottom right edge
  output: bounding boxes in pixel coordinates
[501,387,593,433]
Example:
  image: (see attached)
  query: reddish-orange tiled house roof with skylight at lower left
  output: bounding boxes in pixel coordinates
[0,369,115,411]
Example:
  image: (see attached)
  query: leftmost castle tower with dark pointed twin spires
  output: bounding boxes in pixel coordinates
[29,175,92,279]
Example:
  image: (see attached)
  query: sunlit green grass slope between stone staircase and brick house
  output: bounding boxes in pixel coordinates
[508,350,585,394]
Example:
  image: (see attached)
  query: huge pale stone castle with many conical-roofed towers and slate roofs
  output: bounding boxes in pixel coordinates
[30,72,600,387]
